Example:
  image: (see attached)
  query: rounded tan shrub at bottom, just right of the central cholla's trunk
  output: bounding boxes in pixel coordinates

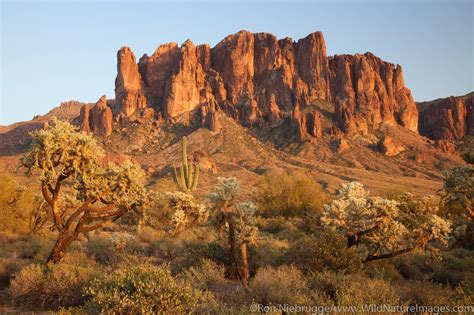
[250,266,309,305]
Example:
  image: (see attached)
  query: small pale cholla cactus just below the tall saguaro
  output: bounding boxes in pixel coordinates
[166,191,208,236]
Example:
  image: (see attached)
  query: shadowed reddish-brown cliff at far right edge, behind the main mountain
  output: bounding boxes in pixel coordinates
[418,92,474,140]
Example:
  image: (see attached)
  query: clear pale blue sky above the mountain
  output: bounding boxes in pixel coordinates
[0,0,474,124]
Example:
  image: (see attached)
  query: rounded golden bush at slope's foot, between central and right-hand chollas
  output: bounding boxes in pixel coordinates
[257,173,329,217]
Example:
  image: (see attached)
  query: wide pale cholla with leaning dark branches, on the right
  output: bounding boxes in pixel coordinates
[321,182,451,262]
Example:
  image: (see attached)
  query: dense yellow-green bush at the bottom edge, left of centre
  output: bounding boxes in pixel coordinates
[86,263,198,314]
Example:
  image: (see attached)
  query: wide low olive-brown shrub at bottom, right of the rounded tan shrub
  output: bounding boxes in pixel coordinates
[307,272,399,306]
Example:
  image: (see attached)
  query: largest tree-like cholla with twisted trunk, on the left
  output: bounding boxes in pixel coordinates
[22,119,146,263]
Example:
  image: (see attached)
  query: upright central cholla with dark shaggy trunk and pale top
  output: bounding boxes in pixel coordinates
[206,177,258,288]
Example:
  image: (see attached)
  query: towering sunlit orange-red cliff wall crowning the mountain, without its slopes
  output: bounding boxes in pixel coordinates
[105,31,418,139]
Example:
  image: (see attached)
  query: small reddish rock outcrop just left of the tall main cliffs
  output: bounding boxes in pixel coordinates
[79,95,113,137]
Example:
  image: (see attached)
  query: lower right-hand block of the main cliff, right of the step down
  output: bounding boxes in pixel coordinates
[329,53,418,133]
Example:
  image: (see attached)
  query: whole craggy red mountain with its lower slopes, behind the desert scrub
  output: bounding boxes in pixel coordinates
[0,31,473,193]
